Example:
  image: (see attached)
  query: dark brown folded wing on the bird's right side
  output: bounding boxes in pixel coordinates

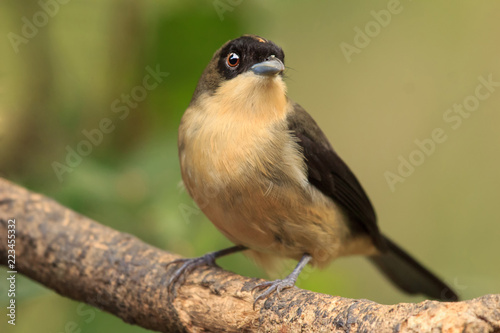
[287,104,385,249]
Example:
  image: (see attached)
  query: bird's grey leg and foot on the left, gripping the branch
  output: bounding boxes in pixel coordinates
[167,245,247,297]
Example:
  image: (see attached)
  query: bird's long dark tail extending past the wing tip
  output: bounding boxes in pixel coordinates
[369,233,458,302]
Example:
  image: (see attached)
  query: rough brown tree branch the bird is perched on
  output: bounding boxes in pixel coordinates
[0,179,500,333]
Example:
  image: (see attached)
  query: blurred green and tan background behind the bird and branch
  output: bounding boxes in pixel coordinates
[0,0,500,333]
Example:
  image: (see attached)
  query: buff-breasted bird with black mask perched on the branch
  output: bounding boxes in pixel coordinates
[168,35,458,307]
